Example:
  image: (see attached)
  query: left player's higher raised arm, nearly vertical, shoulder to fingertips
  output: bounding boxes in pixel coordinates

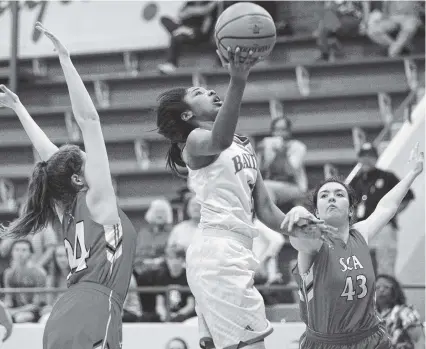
[36,23,119,225]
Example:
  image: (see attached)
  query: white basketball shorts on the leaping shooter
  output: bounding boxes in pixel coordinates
[186,229,273,349]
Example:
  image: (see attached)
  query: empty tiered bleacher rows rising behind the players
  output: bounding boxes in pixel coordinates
[0,2,425,234]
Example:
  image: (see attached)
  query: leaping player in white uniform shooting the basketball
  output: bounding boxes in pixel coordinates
[157,48,338,349]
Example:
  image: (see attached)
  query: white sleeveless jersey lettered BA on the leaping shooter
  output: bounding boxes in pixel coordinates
[188,137,257,238]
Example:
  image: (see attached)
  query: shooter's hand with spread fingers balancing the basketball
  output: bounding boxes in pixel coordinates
[216,47,262,80]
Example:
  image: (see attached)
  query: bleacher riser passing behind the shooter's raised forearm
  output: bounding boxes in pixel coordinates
[15,56,424,107]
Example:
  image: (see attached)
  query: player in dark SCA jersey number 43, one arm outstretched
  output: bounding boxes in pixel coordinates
[285,142,424,349]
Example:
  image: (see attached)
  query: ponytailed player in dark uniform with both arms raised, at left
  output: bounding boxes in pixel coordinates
[0,23,136,349]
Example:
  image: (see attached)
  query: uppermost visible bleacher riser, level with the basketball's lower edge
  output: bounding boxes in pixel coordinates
[0,34,425,76]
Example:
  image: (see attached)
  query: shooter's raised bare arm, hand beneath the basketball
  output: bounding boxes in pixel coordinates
[186,47,259,156]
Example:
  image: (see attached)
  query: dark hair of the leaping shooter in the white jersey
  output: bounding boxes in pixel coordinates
[157,88,195,177]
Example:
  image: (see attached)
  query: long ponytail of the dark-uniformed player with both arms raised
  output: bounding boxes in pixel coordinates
[0,161,54,239]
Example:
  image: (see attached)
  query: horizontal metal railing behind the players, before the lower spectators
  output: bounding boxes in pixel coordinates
[0,284,425,321]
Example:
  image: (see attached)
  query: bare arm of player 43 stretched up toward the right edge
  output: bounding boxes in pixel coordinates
[354,144,424,241]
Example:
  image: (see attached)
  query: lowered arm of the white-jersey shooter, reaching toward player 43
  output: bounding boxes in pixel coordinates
[253,171,336,244]
